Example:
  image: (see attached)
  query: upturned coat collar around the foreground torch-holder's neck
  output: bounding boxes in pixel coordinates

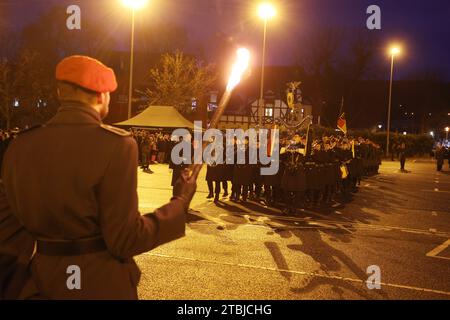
[47,101,102,125]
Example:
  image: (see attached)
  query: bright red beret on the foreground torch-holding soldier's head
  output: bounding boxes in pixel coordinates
[56,56,117,93]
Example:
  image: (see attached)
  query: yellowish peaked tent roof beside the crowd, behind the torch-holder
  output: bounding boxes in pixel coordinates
[116,106,194,129]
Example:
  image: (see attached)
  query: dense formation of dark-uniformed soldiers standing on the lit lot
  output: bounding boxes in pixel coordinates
[202,134,382,214]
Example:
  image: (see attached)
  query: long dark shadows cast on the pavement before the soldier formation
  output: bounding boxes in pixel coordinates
[185,176,410,299]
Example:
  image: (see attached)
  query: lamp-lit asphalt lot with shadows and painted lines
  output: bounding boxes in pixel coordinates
[136,160,450,300]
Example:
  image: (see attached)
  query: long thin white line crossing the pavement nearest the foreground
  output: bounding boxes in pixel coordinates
[142,252,450,296]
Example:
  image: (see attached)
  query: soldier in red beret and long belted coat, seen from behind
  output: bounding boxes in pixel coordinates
[0,56,196,299]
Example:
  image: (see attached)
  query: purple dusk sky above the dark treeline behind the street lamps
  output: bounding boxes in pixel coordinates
[0,0,450,80]
